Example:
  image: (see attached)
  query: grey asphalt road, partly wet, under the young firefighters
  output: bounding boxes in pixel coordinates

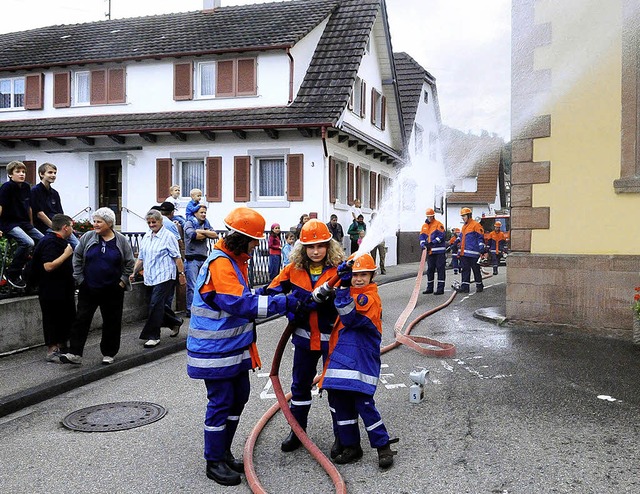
[0,274,640,494]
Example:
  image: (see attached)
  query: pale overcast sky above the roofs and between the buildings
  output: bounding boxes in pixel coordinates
[0,0,511,140]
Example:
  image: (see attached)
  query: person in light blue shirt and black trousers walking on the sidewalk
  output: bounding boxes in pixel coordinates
[130,210,186,348]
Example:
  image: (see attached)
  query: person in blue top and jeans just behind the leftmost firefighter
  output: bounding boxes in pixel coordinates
[184,204,218,317]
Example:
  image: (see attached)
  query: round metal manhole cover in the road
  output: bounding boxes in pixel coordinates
[62,401,167,432]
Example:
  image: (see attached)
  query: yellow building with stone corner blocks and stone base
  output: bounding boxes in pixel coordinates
[507,0,640,330]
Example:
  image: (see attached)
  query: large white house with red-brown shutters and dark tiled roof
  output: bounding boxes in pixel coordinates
[0,0,439,264]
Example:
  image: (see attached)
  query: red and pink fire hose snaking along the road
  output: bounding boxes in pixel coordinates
[244,250,490,494]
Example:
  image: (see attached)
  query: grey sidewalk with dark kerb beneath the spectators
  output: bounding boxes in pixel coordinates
[0,263,419,417]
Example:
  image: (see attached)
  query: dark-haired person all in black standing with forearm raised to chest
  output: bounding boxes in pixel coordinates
[31,214,76,362]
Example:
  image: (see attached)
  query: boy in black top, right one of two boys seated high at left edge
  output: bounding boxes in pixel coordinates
[31,163,78,249]
